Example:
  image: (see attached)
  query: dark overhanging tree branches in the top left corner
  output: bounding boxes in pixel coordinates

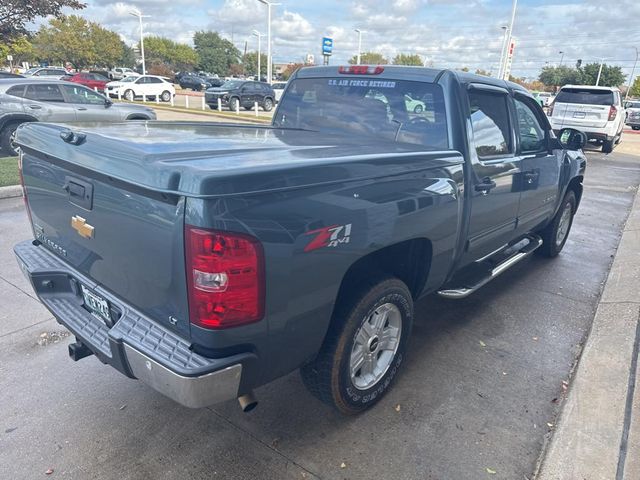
[0,0,86,43]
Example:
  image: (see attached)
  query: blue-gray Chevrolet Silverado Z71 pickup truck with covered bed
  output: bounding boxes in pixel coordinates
[15,66,586,414]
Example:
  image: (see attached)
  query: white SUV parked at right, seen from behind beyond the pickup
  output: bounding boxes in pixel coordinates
[549,85,625,153]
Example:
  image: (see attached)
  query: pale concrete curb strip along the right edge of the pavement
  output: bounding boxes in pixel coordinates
[536,185,640,480]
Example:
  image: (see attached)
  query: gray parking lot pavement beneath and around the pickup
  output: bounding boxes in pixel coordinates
[0,135,640,480]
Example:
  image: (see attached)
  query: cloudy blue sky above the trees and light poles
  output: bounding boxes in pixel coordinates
[66,0,640,79]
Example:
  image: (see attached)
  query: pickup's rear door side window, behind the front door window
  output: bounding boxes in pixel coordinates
[469,89,513,159]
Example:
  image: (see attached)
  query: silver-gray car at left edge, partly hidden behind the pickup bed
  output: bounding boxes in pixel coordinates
[0,78,156,154]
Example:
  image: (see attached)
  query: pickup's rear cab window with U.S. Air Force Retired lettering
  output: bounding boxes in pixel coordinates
[274,77,449,148]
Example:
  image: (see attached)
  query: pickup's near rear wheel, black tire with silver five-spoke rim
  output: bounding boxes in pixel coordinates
[300,278,413,415]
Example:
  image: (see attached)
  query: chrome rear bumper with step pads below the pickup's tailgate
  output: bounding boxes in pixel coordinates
[14,241,250,408]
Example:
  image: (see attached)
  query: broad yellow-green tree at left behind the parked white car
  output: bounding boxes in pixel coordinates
[34,15,125,68]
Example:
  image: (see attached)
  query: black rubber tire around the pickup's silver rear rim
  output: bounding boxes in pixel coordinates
[300,278,413,415]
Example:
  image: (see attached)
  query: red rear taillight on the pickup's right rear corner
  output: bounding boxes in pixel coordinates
[184,225,264,329]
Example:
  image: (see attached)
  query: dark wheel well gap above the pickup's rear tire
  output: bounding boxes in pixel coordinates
[336,238,433,304]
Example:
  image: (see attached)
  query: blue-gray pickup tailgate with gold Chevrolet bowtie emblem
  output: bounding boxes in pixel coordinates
[22,140,189,338]
